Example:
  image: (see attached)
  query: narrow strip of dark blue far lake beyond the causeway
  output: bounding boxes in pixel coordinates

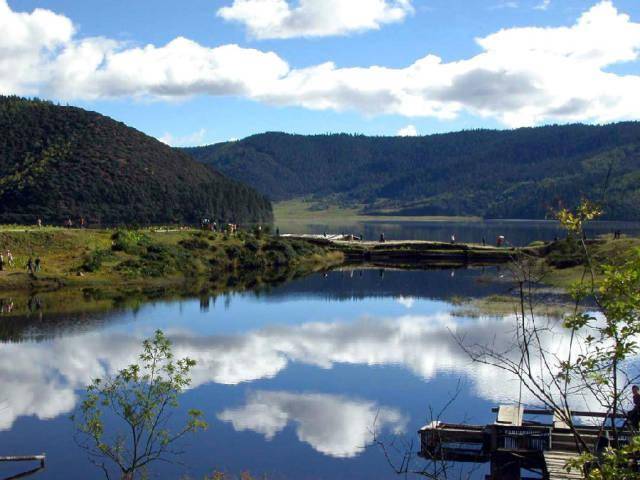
[281,220,640,246]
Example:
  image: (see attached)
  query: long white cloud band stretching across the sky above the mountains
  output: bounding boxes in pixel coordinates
[0,0,640,126]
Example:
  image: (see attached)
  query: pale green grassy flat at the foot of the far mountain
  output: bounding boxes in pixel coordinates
[273,199,479,231]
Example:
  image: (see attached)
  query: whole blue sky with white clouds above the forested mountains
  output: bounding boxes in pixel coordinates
[0,0,640,146]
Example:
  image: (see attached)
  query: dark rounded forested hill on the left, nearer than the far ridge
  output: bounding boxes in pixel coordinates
[0,97,272,225]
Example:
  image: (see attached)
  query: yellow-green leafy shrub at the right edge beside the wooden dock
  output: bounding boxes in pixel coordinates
[558,201,640,474]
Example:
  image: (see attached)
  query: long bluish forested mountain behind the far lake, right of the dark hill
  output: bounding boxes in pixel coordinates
[186,122,640,219]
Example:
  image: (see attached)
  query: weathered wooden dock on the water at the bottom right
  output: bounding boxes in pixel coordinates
[419,407,631,480]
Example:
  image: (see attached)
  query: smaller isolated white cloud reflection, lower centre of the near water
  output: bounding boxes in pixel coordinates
[218,390,407,457]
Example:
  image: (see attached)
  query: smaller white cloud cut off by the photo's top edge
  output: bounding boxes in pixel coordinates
[218,0,413,39]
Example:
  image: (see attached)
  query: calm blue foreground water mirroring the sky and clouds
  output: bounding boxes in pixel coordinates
[0,218,637,480]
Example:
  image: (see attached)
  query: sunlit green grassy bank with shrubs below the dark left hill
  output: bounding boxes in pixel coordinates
[0,226,342,292]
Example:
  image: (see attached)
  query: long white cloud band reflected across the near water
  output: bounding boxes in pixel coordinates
[0,313,580,432]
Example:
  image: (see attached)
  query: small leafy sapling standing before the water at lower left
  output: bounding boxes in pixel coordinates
[74,330,207,480]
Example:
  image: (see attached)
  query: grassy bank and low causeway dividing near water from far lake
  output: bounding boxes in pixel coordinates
[0,226,640,316]
